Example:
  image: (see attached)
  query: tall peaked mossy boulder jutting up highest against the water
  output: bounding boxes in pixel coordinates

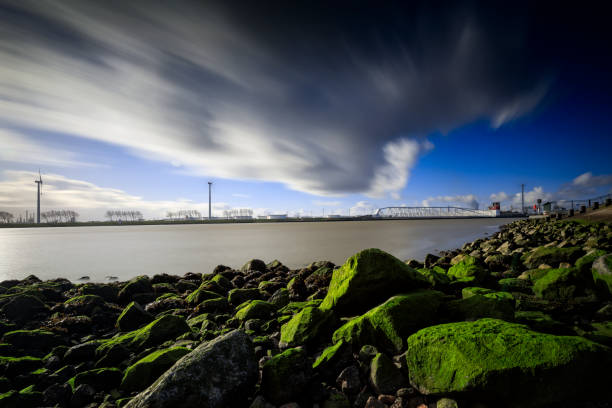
[320,249,430,316]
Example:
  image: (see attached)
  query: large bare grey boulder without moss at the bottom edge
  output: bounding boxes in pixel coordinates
[125,330,258,408]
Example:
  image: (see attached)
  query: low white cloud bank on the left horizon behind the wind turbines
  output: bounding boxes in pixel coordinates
[0,170,231,220]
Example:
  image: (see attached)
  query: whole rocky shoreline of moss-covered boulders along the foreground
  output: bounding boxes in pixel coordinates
[0,220,612,408]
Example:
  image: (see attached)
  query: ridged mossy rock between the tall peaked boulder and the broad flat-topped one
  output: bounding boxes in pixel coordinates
[332,290,444,353]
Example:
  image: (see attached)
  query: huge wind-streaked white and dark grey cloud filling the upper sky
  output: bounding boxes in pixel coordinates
[0,1,548,198]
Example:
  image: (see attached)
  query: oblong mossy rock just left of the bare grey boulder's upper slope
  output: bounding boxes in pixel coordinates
[121,347,190,391]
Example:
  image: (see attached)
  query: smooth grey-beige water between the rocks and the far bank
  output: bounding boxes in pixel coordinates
[0,219,512,282]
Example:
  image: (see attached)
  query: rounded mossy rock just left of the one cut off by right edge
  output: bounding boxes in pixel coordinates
[533,268,588,300]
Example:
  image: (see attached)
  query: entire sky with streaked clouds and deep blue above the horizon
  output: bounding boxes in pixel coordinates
[0,0,612,220]
